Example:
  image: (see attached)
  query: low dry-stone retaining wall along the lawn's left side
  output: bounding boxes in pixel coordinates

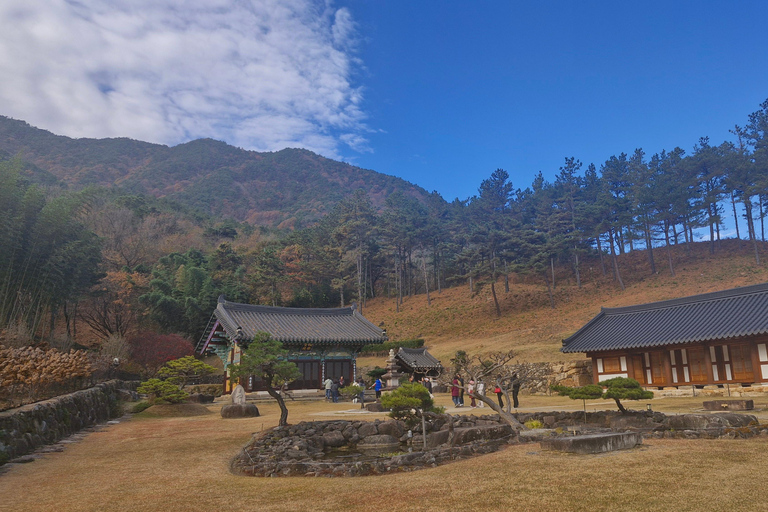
[0,380,138,464]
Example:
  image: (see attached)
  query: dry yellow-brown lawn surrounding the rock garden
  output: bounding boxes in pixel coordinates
[0,395,768,512]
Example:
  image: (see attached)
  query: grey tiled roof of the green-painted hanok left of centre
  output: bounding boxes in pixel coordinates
[215,298,387,345]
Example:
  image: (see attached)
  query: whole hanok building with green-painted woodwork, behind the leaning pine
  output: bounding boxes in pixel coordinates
[200,297,387,391]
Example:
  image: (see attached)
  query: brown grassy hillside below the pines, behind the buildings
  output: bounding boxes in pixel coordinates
[360,240,768,366]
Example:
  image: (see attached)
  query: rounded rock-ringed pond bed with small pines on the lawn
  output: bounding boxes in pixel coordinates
[232,415,517,476]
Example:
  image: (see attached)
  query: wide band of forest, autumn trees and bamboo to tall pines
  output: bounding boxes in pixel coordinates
[0,97,768,343]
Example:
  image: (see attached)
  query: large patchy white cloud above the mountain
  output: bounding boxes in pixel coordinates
[0,0,367,158]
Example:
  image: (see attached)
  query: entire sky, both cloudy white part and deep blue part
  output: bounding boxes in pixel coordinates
[0,0,768,201]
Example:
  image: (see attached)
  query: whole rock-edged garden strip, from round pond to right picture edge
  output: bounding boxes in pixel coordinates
[232,411,768,477]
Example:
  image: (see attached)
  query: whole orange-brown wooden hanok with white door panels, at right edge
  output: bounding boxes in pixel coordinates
[561,283,768,388]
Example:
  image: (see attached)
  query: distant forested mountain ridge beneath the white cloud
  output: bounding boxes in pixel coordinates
[0,116,428,228]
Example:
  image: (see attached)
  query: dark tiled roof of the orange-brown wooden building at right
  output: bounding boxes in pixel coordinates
[561,283,768,352]
